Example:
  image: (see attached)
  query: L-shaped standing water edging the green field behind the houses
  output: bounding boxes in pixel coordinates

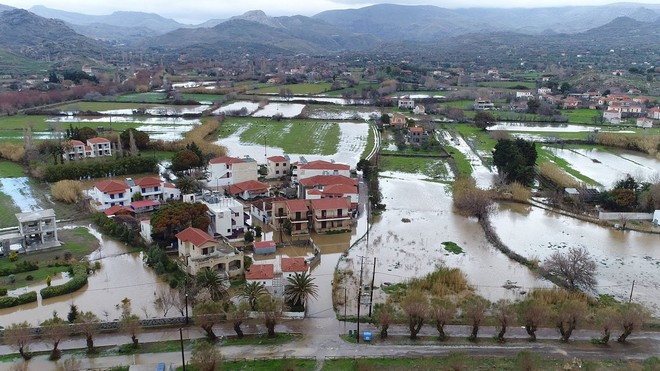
[216,122,369,166]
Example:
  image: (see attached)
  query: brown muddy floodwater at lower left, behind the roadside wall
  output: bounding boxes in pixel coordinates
[0,229,170,326]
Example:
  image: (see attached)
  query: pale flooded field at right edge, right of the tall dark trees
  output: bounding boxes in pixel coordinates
[547,147,660,189]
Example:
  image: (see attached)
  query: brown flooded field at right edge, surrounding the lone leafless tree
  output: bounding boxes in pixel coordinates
[492,204,660,315]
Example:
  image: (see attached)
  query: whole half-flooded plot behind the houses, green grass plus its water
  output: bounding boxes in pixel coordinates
[217,118,370,165]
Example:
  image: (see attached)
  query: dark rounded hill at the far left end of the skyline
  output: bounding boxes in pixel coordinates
[0,9,107,61]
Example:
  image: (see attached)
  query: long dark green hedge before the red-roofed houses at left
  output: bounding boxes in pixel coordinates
[43,156,158,183]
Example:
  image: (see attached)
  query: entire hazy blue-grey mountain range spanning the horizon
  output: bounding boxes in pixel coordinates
[0,3,660,71]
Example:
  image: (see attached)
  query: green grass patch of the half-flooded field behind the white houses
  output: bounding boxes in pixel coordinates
[219,118,340,155]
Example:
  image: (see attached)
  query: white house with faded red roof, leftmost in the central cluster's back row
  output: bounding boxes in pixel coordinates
[206,156,259,188]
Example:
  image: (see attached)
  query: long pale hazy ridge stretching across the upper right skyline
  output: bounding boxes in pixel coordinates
[313,3,660,41]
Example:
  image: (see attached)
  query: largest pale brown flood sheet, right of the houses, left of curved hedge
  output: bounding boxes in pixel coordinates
[339,172,553,314]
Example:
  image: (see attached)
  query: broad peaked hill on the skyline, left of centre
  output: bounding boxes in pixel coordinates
[145,12,378,54]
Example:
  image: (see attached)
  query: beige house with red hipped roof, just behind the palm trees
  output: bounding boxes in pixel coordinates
[175,227,243,277]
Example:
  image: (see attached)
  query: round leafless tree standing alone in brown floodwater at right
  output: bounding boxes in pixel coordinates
[542,247,596,291]
